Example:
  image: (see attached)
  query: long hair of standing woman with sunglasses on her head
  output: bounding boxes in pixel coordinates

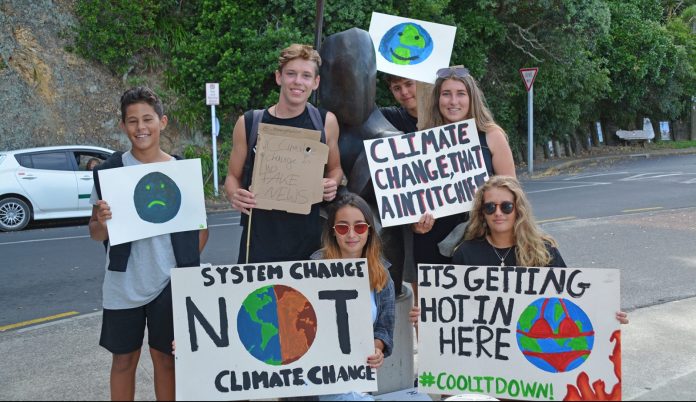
[423,66,507,138]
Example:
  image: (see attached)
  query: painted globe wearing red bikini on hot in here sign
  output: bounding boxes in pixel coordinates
[517,297,594,373]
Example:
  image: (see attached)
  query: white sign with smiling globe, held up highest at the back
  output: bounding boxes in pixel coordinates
[369,12,457,84]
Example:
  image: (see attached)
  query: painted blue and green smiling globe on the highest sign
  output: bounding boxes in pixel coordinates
[379,22,433,65]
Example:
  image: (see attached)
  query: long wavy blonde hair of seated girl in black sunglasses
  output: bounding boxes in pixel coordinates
[464,176,558,267]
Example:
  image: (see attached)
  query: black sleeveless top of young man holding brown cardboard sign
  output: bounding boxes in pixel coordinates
[238,108,327,264]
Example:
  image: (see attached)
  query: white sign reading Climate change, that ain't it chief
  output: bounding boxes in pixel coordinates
[364,119,488,227]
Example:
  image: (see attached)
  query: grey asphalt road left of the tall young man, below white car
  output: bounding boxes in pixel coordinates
[0,213,241,331]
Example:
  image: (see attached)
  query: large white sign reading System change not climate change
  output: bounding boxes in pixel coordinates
[172,259,377,400]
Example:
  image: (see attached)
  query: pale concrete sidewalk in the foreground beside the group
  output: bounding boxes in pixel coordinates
[0,298,696,400]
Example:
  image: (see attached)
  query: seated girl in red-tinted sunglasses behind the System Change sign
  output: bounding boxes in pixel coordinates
[312,193,396,401]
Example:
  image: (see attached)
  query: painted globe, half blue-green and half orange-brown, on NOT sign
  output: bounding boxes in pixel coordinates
[237,285,317,366]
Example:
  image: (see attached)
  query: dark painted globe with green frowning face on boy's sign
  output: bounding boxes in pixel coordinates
[133,172,181,223]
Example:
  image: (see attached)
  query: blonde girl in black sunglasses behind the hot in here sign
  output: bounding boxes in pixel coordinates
[410,176,628,324]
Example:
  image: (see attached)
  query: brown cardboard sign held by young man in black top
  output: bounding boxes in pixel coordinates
[250,123,329,215]
